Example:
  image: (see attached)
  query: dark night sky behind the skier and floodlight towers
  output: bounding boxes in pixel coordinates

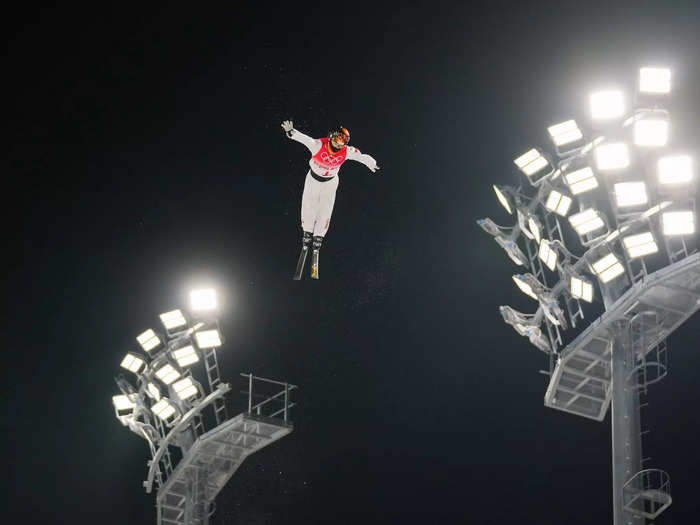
[2,1,700,525]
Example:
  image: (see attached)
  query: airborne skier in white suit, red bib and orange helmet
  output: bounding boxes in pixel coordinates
[282,120,379,280]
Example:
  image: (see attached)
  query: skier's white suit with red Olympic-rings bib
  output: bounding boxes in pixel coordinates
[286,129,378,237]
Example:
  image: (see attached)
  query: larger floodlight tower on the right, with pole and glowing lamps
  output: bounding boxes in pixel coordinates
[477,67,700,525]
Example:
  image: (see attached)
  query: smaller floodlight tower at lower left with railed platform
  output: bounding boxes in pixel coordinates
[112,290,296,525]
